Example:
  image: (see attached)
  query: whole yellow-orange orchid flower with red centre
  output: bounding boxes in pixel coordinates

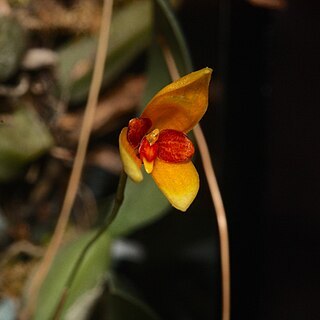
[119,68,212,211]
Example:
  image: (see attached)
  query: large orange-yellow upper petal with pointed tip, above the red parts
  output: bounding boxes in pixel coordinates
[141,68,212,133]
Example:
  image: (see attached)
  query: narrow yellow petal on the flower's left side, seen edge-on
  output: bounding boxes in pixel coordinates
[119,127,143,182]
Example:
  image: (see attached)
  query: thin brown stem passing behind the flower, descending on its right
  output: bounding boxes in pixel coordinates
[161,39,231,320]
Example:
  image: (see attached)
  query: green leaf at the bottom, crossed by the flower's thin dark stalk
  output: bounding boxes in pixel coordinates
[34,232,111,320]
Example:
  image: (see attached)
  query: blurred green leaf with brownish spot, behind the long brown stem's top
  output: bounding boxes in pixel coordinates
[57,0,152,103]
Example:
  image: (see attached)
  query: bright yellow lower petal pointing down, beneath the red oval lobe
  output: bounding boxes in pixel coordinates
[151,159,199,211]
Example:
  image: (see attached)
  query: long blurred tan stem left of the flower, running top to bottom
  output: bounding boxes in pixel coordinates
[20,0,113,319]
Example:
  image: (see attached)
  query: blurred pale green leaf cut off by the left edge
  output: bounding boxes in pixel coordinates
[0,108,53,181]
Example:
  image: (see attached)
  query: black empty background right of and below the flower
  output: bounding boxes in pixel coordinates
[122,0,320,320]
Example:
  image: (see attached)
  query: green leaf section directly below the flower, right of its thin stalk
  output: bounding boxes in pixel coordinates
[109,173,170,236]
